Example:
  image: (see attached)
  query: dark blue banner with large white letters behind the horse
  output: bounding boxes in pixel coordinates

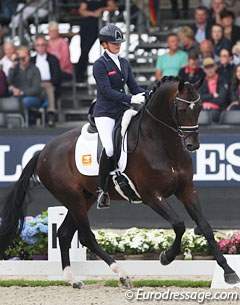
[0,134,240,187]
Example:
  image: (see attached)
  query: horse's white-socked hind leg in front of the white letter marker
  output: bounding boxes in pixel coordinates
[58,212,82,288]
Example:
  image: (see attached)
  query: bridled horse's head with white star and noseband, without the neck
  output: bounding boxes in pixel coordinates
[173,80,202,151]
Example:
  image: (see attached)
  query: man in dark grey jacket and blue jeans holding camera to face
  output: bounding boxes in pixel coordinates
[8,46,41,122]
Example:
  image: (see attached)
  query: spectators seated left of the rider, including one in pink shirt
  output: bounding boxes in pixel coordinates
[0,21,70,127]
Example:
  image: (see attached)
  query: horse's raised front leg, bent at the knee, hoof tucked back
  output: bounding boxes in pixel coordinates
[148,196,185,265]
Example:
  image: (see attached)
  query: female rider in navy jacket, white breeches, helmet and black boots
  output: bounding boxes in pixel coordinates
[93,24,145,208]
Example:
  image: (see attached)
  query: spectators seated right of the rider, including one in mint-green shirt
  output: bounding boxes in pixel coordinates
[156,0,240,123]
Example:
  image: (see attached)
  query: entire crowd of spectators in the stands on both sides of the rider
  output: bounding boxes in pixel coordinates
[0,0,240,127]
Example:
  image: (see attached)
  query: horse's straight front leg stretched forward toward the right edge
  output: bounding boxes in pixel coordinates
[176,185,240,284]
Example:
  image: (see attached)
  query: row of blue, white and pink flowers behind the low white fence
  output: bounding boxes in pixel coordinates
[5,211,240,259]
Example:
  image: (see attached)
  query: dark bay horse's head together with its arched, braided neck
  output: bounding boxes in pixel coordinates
[146,76,202,151]
